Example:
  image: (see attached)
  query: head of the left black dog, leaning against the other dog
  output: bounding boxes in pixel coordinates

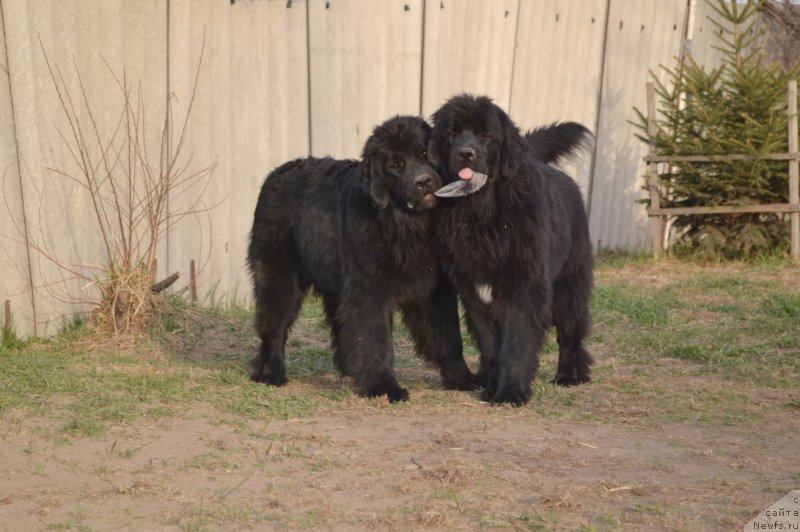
[361,116,442,212]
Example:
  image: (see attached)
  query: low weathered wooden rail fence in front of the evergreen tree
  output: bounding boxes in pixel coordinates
[644,80,800,261]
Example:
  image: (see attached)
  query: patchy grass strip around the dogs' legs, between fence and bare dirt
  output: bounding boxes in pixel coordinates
[0,256,800,437]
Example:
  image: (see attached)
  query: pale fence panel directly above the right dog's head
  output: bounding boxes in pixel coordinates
[422,0,519,117]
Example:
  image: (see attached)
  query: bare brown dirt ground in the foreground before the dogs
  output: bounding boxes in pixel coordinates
[0,260,800,530]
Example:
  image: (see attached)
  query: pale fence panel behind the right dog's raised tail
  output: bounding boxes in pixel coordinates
[510,0,607,198]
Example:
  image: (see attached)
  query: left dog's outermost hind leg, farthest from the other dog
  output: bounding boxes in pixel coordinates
[250,261,306,386]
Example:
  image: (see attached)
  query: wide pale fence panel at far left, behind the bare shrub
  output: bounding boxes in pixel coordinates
[2,0,166,334]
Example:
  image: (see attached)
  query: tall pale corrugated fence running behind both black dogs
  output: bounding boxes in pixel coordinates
[0,0,744,336]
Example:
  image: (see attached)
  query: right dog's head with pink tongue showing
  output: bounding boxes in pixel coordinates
[428,94,522,189]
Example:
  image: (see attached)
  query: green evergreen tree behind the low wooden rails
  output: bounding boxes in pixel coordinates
[635,0,800,258]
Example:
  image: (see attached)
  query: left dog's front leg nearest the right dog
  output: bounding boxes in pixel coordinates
[402,279,480,390]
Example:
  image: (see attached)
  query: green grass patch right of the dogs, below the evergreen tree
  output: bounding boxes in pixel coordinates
[593,267,800,387]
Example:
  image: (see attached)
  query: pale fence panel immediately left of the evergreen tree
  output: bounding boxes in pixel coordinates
[590,0,687,249]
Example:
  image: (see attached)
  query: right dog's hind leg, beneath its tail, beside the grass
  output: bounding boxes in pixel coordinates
[552,260,593,386]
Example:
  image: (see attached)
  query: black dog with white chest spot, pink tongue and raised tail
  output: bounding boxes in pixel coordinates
[429,95,593,405]
